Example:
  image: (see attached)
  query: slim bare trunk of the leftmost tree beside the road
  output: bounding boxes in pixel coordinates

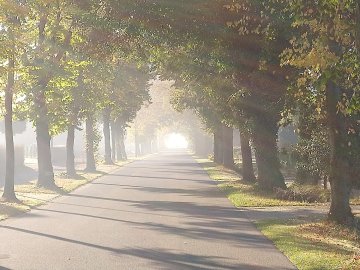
[2,33,18,202]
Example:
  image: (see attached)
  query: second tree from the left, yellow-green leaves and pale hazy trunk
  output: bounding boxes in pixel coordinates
[16,1,77,188]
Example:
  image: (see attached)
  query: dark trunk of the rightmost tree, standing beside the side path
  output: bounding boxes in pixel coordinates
[326,81,354,225]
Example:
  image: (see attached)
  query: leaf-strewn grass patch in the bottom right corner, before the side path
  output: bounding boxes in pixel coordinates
[256,220,360,270]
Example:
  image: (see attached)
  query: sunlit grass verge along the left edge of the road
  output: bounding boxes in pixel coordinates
[0,160,132,220]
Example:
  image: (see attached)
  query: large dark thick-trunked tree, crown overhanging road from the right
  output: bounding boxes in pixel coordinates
[131,1,289,186]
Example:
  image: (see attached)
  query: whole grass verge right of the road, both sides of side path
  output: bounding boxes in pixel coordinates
[197,159,360,270]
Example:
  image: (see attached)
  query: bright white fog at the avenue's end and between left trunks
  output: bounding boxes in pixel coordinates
[0,80,213,185]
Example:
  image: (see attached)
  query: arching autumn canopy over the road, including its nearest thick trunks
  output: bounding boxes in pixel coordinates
[0,0,360,223]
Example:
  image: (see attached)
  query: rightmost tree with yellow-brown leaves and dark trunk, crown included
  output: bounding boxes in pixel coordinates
[282,0,360,224]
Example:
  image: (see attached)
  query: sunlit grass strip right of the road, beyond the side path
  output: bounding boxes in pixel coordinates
[197,159,312,207]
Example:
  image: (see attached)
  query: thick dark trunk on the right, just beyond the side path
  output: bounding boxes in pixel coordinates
[253,115,286,190]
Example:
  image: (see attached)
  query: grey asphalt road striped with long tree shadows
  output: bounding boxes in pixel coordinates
[0,153,295,270]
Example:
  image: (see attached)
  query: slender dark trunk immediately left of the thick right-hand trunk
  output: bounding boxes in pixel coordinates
[240,129,256,182]
